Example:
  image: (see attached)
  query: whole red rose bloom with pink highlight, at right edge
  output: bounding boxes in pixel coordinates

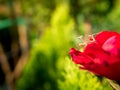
[69,31,120,81]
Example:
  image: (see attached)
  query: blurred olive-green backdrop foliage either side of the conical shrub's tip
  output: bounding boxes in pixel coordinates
[21,0,120,37]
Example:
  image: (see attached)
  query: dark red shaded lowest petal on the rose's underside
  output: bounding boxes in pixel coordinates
[88,62,120,80]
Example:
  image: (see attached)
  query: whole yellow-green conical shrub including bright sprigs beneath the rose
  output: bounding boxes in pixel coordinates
[16,0,112,90]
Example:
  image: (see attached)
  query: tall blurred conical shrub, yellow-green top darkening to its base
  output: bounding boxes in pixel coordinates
[15,3,74,90]
